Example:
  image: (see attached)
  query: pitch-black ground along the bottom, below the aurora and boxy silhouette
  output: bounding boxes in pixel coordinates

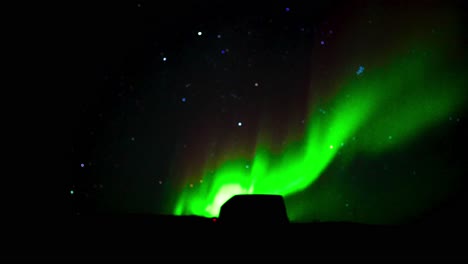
[2,193,468,261]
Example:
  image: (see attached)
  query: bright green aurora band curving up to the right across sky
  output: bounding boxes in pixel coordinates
[174,45,465,220]
